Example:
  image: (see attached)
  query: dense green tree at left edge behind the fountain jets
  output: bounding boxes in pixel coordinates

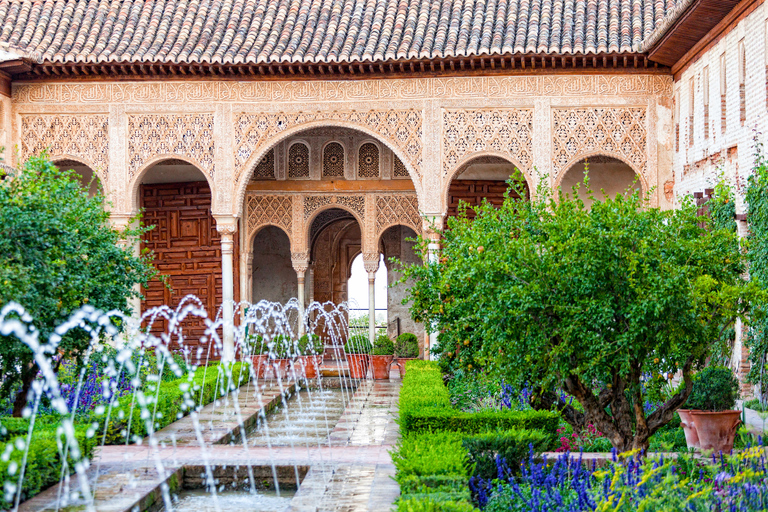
[0,156,155,414]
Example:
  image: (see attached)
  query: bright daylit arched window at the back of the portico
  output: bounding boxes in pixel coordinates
[347,253,389,335]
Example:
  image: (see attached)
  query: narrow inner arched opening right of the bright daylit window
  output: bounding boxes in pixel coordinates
[377,225,424,348]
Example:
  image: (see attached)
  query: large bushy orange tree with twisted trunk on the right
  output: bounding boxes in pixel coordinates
[403,182,758,450]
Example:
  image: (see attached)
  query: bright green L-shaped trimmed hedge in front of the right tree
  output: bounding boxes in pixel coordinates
[399,361,560,438]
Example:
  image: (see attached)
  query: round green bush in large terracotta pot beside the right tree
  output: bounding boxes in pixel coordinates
[680,366,741,453]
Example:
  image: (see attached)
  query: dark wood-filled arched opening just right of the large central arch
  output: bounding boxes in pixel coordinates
[447,156,530,219]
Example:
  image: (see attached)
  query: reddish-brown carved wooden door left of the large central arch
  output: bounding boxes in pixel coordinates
[140,182,239,359]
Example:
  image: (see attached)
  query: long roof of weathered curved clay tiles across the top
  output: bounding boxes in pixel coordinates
[0,0,682,64]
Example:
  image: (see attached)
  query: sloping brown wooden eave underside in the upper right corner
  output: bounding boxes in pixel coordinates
[648,0,744,68]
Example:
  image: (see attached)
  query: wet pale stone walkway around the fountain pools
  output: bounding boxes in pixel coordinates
[20,372,400,512]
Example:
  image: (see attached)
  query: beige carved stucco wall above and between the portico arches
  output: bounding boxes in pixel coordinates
[11,74,673,214]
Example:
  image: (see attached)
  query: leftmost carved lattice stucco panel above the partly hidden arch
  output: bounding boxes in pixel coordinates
[20,114,109,186]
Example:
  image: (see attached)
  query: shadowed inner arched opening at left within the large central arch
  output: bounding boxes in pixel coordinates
[251,226,298,304]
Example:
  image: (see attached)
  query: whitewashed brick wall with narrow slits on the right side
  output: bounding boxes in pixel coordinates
[673,3,768,393]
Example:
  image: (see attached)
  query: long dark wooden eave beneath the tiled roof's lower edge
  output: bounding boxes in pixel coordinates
[6,53,671,81]
